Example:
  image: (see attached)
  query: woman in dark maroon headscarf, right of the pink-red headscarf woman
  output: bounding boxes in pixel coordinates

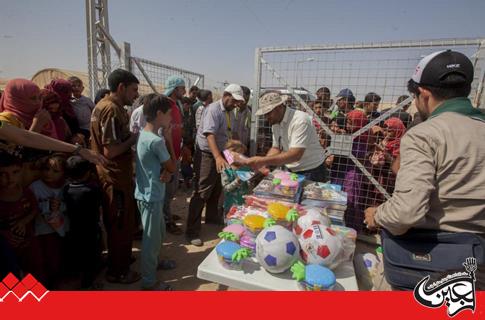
[40,89,71,141]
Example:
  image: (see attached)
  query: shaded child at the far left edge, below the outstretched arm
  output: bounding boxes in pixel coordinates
[0,151,39,279]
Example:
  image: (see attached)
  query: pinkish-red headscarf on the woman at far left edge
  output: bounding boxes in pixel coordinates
[0,79,41,130]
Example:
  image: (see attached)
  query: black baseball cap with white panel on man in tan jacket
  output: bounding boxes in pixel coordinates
[411,50,473,88]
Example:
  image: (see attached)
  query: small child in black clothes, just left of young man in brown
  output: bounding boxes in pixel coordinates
[63,156,101,289]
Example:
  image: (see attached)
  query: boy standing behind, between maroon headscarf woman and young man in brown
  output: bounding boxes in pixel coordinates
[67,76,94,141]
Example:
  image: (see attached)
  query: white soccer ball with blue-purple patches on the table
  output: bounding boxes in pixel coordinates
[256,225,300,273]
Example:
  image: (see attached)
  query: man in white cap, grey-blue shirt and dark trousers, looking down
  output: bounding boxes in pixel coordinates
[185,84,244,246]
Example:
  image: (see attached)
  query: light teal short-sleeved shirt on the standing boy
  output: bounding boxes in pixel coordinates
[134,130,170,202]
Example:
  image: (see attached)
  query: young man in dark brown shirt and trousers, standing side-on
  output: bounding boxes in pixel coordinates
[91,69,140,283]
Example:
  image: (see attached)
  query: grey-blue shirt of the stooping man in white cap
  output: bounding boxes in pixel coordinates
[197,100,234,152]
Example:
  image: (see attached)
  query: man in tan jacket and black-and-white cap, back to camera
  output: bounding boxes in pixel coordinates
[364,50,485,285]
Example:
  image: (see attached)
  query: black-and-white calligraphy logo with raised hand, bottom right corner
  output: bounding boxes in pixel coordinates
[414,258,477,317]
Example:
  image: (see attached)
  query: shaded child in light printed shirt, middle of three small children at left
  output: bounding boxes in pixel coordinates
[30,154,68,288]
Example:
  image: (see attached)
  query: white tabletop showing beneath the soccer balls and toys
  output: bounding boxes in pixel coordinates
[197,249,359,291]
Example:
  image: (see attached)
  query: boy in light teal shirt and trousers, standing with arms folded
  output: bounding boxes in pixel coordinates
[135,95,176,291]
